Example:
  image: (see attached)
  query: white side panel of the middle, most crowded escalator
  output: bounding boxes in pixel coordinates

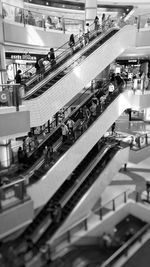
[27,88,132,208]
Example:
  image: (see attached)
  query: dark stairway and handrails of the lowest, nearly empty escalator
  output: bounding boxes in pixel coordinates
[10,139,129,264]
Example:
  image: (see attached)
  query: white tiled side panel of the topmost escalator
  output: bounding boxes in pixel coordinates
[24,25,136,127]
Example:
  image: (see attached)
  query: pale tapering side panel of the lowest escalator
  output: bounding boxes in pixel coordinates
[51,147,130,242]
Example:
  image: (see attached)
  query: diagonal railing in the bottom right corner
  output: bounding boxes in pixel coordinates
[99,224,150,267]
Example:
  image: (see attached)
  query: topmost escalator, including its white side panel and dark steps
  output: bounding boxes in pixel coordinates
[24,25,136,127]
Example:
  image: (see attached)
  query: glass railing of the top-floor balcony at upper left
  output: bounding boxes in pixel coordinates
[2,3,84,33]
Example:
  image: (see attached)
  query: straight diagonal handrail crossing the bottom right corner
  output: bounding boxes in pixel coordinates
[100,223,150,267]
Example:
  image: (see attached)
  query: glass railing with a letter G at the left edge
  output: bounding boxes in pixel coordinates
[0,84,24,111]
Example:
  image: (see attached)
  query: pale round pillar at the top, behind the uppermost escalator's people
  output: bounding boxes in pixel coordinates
[85,0,97,25]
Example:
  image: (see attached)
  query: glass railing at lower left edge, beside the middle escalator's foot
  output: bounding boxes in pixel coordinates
[0,178,29,212]
